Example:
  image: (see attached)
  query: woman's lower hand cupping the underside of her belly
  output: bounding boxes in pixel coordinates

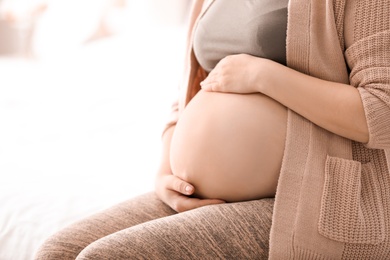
[155,174,224,212]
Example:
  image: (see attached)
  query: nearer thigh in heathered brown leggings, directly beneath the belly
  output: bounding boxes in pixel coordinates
[77,199,274,260]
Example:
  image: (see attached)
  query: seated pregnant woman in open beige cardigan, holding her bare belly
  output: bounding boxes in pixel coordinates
[36,0,390,259]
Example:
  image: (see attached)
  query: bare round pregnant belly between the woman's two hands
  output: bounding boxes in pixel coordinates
[170,90,287,202]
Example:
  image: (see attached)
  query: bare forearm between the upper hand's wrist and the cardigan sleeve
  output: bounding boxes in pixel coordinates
[258,60,368,143]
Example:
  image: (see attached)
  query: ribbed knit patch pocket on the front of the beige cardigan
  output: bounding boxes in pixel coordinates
[318,156,385,244]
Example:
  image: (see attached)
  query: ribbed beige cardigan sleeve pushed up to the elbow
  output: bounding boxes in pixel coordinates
[345,0,390,149]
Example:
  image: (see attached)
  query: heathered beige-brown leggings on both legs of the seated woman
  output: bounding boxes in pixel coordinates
[36,193,274,260]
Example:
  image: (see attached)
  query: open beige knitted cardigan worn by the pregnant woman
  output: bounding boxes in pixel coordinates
[168,0,390,260]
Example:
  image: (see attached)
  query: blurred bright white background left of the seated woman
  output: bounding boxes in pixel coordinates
[0,0,191,260]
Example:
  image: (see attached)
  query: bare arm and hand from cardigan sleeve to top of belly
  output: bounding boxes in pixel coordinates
[201,54,368,143]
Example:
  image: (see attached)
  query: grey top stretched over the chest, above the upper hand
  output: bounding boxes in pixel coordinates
[194,0,288,71]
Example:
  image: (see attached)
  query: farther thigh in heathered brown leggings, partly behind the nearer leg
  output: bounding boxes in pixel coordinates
[35,193,176,259]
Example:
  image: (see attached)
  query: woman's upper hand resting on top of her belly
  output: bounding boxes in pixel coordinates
[201,54,264,94]
